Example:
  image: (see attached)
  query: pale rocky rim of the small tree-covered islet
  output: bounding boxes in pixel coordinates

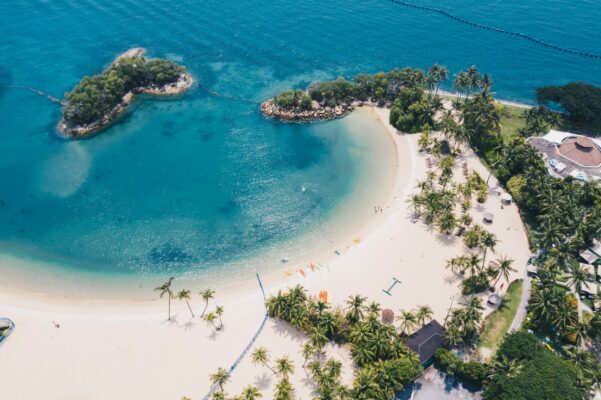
[57,47,194,139]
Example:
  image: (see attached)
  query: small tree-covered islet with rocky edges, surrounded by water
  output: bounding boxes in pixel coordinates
[58,48,194,138]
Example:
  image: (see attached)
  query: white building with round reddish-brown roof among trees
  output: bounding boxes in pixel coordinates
[527,130,601,181]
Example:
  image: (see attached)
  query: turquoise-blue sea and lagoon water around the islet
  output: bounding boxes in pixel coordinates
[0,0,601,288]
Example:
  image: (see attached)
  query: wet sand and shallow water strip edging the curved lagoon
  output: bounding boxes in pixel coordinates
[0,106,408,308]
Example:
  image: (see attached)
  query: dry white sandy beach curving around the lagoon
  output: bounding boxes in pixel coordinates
[0,109,529,400]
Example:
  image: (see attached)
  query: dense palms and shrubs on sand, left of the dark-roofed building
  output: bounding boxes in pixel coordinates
[267,286,424,400]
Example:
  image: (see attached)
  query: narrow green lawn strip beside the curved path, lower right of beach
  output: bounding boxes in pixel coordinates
[478,279,523,357]
